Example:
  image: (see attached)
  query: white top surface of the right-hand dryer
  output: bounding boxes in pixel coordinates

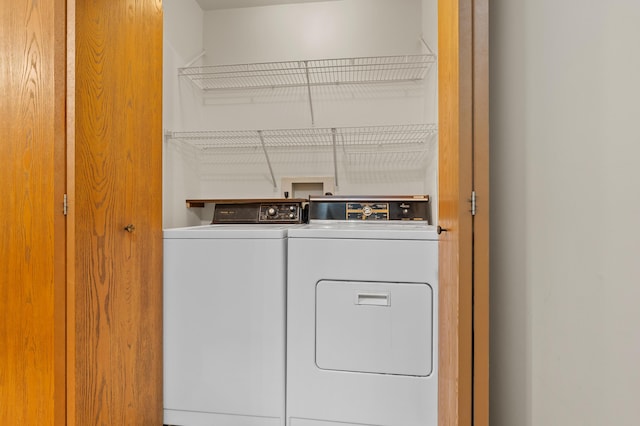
[289,220,438,241]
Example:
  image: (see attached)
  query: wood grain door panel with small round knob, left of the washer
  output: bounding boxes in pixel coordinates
[74,0,162,425]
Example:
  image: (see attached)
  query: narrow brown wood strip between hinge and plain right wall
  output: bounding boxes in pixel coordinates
[473,0,489,426]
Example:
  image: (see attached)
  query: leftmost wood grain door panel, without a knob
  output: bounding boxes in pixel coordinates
[0,0,65,425]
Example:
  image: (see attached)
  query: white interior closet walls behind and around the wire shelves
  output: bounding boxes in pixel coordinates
[165,0,437,226]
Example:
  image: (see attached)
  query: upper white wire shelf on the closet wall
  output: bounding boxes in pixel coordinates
[178,53,436,90]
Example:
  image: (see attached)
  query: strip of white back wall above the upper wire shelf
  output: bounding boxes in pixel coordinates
[204,0,422,64]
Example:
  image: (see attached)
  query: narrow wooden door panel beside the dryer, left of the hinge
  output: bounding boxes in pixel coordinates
[438,0,473,426]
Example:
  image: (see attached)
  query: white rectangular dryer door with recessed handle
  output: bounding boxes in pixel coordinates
[316,280,433,376]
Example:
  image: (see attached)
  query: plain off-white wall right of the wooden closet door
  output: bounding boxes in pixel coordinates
[490,0,640,426]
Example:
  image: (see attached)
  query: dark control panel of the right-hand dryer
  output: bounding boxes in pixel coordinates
[309,195,431,223]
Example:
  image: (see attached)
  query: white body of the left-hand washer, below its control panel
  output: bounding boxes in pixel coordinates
[164,225,287,426]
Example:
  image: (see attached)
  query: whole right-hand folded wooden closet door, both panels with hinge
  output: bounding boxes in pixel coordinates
[438,0,489,426]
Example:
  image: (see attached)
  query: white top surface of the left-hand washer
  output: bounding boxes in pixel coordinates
[163,224,291,239]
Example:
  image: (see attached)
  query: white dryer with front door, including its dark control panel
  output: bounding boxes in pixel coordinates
[287,197,438,426]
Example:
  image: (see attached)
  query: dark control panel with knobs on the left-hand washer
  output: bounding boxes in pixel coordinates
[211,200,304,224]
